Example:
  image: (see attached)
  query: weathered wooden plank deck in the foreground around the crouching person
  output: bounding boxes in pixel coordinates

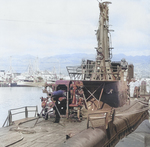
[0,99,149,147]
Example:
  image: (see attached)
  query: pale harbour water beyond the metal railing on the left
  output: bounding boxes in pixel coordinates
[0,87,46,127]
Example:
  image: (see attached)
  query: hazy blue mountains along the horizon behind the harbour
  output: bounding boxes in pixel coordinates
[0,53,150,77]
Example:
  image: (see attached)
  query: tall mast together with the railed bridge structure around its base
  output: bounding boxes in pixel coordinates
[80,2,133,81]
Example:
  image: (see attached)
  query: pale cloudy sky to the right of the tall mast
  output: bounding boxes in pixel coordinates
[111,0,150,55]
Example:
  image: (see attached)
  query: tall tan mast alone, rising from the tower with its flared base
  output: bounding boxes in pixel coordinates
[91,2,113,80]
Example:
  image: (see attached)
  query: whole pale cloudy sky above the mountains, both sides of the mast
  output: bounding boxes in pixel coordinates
[0,0,150,57]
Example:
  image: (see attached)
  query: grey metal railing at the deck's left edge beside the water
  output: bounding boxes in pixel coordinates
[2,106,38,127]
